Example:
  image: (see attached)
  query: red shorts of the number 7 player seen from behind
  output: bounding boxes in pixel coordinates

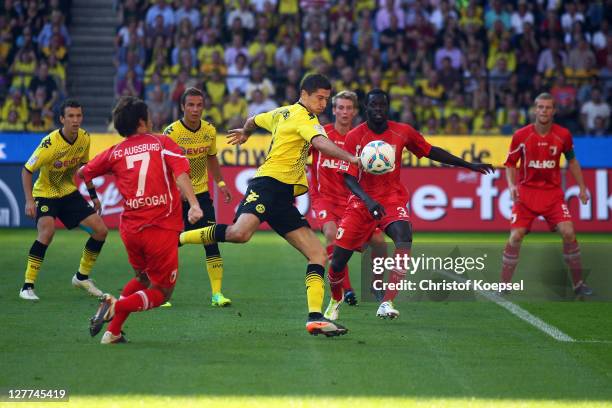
[121,227,179,288]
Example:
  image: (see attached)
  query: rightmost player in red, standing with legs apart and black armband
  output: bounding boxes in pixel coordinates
[501,93,593,297]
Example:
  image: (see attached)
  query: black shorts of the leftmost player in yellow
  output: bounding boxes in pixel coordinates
[34,190,96,229]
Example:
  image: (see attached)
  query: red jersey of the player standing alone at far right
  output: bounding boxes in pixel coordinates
[504,124,574,189]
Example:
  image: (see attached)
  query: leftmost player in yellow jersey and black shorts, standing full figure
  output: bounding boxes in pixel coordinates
[19,99,108,300]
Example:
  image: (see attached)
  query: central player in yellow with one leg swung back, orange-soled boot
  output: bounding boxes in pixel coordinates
[180,74,360,336]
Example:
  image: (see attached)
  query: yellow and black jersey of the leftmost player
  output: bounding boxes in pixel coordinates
[25,129,90,198]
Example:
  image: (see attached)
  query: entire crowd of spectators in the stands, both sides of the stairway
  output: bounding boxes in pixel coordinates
[0,0,612,135]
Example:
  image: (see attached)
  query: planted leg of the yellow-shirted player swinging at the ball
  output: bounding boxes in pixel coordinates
[284,225,348,336]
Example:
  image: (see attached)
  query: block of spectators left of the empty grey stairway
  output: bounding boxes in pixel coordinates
[0,0,70,132]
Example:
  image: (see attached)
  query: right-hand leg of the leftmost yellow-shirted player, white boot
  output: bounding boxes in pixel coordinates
[72,213,108,296]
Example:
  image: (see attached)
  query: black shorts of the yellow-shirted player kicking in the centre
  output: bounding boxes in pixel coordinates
[234,177,310,236]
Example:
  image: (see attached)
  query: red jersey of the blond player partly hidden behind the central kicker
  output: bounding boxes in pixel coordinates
[310,123,351,203]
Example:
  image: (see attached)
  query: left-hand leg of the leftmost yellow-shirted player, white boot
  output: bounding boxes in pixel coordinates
[19,210,55,300]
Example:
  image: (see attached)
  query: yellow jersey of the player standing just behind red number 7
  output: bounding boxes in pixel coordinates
[164,119,217,194]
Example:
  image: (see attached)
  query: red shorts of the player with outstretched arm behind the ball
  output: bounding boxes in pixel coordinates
[336,199,410,251]
